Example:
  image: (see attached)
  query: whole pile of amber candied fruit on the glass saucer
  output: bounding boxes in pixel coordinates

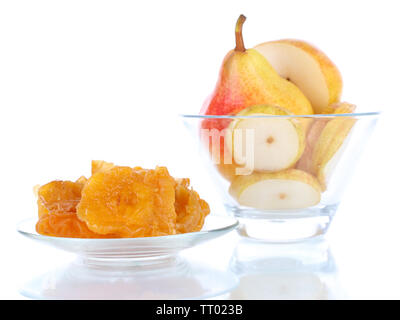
[34,160,210,238]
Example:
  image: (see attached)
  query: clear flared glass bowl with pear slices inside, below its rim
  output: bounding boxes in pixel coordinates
[182,112,379,242]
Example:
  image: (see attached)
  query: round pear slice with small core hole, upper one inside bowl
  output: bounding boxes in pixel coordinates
[225,105,305,173]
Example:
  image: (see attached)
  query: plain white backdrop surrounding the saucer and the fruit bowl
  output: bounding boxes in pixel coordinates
[0,0,400,298]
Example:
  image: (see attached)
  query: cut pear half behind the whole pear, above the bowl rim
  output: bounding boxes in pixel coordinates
[254,39,342,114]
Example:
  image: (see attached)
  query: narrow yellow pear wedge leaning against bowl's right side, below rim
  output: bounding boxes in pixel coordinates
[311,117,356,190]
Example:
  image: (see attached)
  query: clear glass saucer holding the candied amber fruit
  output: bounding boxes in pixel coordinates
[17,215,238,269]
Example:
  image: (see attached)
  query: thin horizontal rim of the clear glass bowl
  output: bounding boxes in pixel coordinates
[180,111,382,119]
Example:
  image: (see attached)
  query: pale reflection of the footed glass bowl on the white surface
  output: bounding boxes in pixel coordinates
[230,239,344,300]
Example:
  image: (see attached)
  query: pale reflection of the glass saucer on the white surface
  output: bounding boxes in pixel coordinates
[21,257,238,299]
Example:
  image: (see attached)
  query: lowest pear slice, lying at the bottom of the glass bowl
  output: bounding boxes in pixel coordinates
[229,169,321,210]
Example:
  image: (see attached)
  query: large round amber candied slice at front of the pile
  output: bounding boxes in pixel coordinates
[77,166,176,237]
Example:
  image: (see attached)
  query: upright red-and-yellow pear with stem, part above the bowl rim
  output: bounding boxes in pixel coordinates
[201,15,313,129]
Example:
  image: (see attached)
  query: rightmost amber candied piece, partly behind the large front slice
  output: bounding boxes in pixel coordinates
[175,179,210,233]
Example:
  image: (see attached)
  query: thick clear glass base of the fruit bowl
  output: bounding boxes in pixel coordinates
[227,205,337,243]
